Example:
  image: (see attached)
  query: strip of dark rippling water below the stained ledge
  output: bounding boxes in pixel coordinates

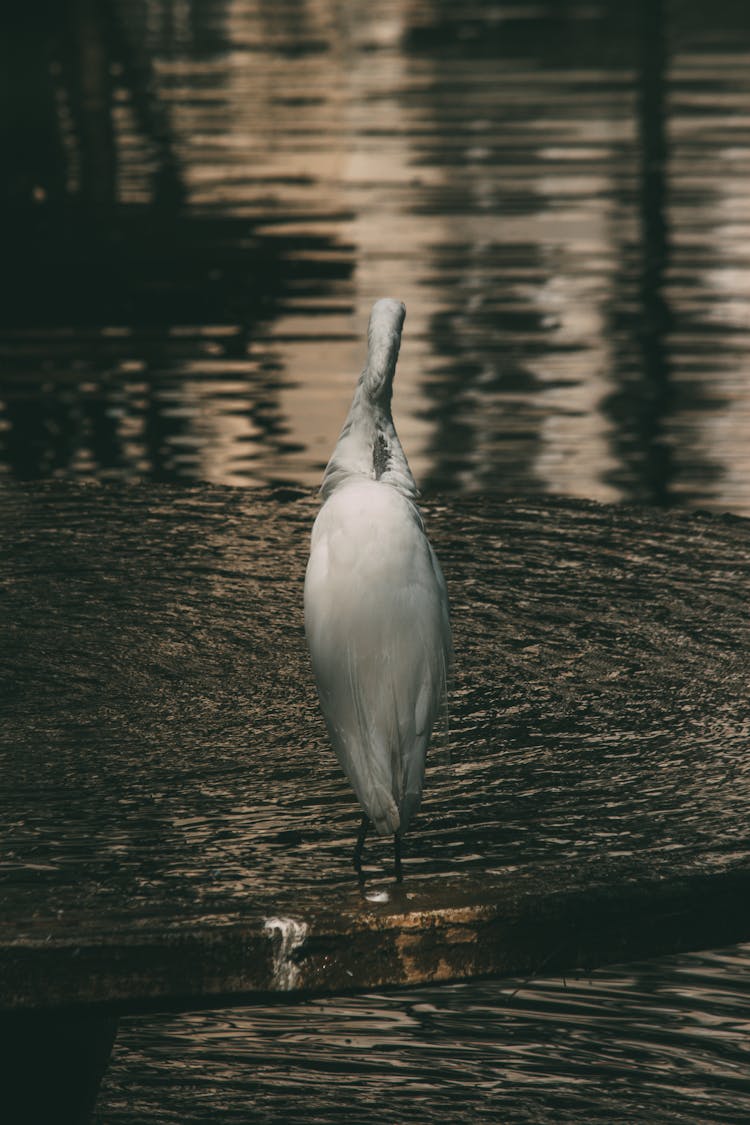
[98,946,750,1125]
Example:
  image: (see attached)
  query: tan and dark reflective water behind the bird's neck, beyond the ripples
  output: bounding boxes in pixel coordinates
[0,0,750,512]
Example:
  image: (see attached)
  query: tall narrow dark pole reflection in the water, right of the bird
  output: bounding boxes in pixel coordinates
[638,0,672,504]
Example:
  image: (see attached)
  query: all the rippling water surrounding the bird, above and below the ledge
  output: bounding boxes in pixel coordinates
[0,0,750,1125]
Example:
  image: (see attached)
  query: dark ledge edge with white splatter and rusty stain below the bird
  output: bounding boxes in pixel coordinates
[0,871,750,1014]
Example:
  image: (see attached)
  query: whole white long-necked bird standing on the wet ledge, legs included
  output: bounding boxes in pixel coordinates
[305,298,452,879]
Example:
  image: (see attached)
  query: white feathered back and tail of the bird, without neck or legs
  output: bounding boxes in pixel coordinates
[305,476,451,834]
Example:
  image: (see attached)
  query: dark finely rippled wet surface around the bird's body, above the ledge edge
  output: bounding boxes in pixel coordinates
[0,484,750,999]
